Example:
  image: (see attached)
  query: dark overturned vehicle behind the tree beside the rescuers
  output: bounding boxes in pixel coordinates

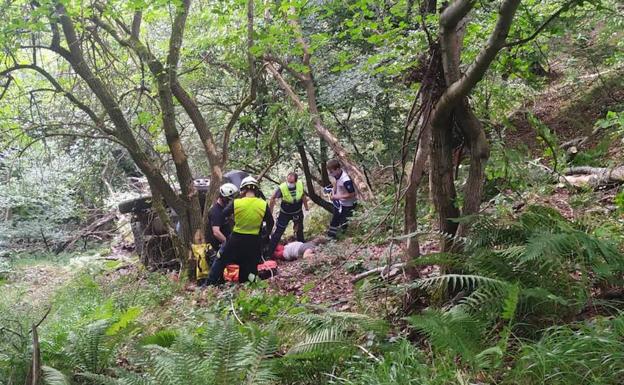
[118,170,249,270]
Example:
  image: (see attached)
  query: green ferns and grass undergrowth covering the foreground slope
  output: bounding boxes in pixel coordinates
[0,206,624,385]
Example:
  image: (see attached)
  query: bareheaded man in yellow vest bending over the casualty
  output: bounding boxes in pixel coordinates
[266,172,309,258]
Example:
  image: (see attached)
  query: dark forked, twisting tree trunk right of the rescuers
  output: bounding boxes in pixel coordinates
[430,0,520,250]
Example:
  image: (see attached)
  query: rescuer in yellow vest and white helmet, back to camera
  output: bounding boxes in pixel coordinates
[208,176,274,285]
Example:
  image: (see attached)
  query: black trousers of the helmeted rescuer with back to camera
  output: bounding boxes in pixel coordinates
[208,233,262,285]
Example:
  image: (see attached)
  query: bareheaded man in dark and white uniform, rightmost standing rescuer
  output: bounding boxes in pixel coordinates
[326,159,357,239]
